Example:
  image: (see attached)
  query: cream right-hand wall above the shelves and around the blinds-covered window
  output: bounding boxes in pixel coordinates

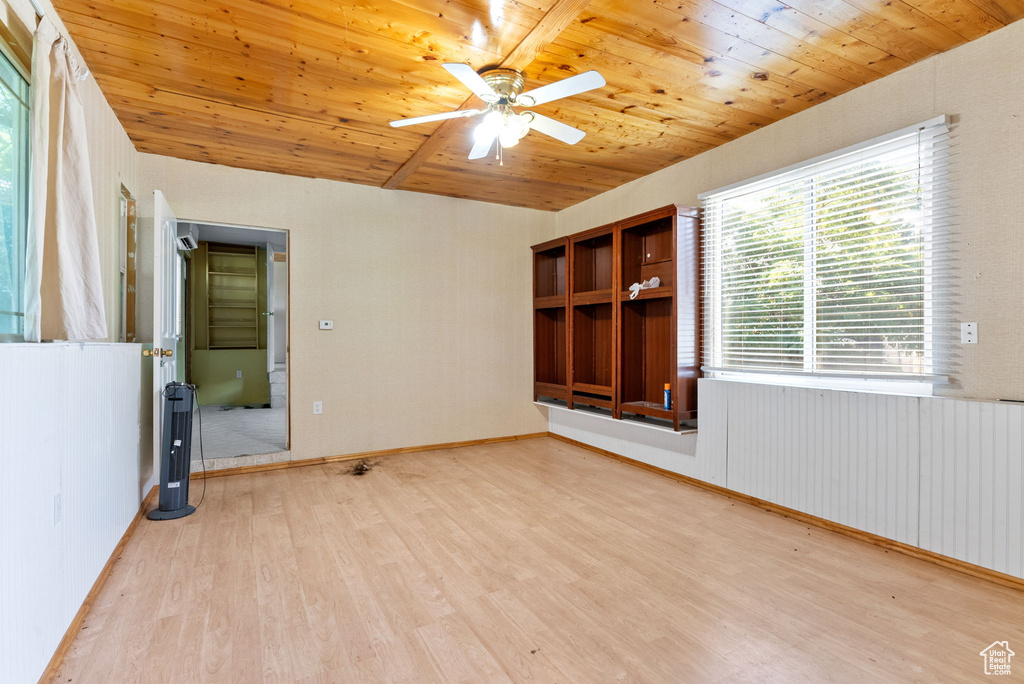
[557,17,1024,399]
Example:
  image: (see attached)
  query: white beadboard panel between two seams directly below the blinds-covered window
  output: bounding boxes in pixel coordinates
[729,383,919,545]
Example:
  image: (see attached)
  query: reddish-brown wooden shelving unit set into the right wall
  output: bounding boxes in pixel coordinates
[534,205,700,430]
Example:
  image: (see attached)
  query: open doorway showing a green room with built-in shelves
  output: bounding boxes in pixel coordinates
[179,221,290,469]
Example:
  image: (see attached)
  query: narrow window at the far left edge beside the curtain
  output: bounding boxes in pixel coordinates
[0,54,29,340]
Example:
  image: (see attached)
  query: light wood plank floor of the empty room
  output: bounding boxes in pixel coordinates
[56,438,1024,684]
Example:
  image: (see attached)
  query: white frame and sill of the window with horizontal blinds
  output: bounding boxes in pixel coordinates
[698,116,950,395]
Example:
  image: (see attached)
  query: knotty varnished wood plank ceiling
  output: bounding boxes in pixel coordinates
[54,0,1024,210]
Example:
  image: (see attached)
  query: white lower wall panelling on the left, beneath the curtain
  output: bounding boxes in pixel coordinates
[0,344,148,682]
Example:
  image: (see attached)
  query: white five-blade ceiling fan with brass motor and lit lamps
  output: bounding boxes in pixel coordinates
[391,63,605,160]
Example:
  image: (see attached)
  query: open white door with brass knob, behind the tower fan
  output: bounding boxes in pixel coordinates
[153,190,182,478]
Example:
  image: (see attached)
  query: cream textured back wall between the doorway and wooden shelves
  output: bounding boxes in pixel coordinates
[141,155,555,460]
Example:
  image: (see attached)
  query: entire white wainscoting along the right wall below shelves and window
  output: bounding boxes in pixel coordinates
[548,380,1024,578]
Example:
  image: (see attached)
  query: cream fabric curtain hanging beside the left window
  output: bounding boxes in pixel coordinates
[25,16,106,342]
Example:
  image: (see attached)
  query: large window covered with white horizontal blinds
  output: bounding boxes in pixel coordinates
[701,117,948,382]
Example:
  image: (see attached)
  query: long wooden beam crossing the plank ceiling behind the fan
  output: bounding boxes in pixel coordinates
[383,0,590,189]
